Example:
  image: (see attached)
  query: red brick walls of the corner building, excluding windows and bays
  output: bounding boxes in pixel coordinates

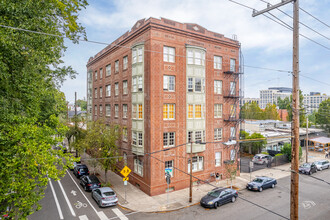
[87,18,240,195]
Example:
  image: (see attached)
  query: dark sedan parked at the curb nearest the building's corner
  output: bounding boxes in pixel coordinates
[200,188,238,209]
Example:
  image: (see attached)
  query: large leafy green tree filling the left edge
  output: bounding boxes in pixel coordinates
[0,0,87,219]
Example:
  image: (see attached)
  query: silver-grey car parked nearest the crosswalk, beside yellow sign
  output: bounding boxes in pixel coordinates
[92,187,118,207]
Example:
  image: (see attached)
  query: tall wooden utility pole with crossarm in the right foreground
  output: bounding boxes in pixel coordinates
[252,0,299,220]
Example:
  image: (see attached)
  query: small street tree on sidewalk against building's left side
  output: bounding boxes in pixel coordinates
[78,119,121,182]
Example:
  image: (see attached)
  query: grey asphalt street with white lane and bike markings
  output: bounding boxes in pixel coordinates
[29,169,330,220]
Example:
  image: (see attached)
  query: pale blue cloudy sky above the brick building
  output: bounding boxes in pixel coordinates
[61,0,330,103]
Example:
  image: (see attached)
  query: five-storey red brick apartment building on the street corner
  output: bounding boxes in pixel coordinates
[87,18,240,195]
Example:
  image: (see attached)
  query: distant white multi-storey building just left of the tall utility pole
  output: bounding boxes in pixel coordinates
[259,87,292,109]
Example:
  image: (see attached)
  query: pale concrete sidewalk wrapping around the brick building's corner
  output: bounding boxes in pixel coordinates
[81,151,324,212]
